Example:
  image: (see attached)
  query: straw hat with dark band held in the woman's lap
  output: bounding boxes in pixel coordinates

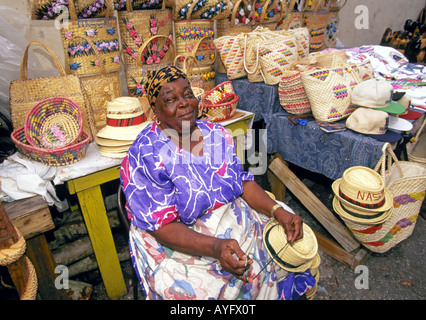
[263,220,318,272]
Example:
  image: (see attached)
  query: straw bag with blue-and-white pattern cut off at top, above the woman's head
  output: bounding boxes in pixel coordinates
[164,0,231,21]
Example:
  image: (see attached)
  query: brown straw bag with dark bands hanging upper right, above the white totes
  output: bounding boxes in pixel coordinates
[303,11,328,52]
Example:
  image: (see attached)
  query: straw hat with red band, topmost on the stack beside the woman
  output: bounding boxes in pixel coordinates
[96,97,149,141]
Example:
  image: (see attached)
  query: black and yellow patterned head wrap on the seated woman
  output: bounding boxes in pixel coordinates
[145,66,189,108]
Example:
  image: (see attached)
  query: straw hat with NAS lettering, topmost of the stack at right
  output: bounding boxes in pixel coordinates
[331,166,393,215]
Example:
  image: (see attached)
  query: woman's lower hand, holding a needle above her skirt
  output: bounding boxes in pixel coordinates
[213,238,253,283]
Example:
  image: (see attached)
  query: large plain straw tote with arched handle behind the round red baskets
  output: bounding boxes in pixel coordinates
[9,41,92,138]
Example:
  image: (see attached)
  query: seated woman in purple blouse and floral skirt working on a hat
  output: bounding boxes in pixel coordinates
[120,66,315,299]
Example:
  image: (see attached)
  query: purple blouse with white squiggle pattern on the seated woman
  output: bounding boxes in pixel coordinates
[120,120,253,231]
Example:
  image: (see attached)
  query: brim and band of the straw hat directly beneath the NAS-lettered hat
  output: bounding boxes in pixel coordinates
[333,196,393,225]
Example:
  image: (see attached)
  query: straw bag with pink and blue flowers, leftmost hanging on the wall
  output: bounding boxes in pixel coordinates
[61,0,121,76]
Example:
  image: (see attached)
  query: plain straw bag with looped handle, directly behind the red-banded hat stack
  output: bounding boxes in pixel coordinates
[69,36,123,136]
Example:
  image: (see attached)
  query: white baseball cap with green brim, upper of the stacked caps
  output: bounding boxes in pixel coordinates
[351,78,405,114]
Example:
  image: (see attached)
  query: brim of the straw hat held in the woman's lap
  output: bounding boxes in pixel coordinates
[263,220,318,272]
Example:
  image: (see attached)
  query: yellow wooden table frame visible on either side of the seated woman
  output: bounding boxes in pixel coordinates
[66,112,254,299]
